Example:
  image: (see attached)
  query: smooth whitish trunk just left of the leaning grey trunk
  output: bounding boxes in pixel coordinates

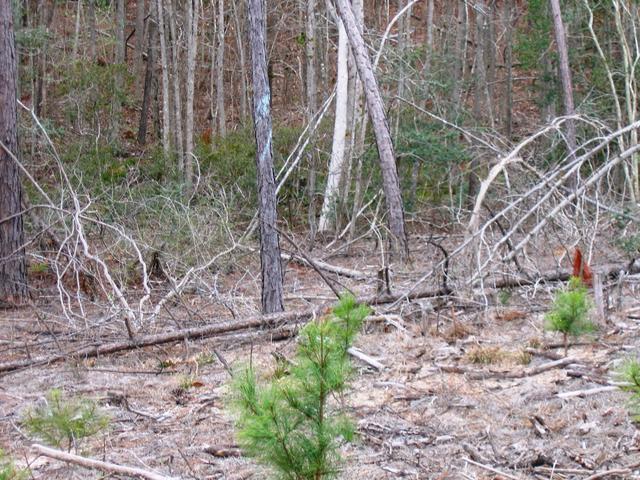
[318,22,349,232]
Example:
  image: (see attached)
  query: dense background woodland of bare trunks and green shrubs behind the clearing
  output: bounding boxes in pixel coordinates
[2,0,640,312]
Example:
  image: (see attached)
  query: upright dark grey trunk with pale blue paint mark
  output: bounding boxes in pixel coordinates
[248,0,284,313]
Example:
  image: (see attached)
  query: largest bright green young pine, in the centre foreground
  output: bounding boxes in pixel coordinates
[232,296,370,480]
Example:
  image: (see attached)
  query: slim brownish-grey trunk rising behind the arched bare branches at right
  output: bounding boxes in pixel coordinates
[550,0,578,186]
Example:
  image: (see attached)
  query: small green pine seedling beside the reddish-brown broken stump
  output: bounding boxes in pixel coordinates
[545,277,596,357]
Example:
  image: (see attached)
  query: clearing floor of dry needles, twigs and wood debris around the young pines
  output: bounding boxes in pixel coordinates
[0,234,640,480]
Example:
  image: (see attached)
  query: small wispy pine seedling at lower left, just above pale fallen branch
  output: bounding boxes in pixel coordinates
[23,389,109,450]
